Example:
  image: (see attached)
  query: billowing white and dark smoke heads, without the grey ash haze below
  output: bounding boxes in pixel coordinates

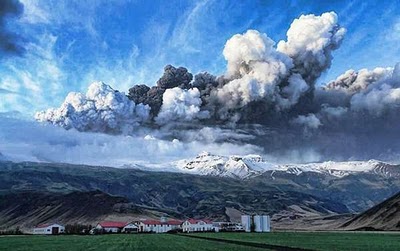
[36,12,345,127]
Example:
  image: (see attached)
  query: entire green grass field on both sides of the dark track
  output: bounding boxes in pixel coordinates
[0,232,400,251]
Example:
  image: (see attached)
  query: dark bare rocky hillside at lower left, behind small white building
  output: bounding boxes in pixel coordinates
[0,191,143,229]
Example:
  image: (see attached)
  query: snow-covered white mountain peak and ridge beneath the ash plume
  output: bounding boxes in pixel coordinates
[170,152,400,179]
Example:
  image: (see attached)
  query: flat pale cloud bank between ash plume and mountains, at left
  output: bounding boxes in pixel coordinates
[0,116,260,167]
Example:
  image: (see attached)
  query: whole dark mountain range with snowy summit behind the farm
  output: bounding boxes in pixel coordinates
[0,158,400,228]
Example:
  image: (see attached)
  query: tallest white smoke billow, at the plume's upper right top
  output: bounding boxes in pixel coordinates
[278,12,346,82]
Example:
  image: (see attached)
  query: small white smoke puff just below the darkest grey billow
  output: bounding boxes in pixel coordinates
[155,87,209,125]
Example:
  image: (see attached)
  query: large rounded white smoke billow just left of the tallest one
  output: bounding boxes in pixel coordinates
[215,30,293,113]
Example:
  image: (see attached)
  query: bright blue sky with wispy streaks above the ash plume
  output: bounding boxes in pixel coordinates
[0,0,400,117]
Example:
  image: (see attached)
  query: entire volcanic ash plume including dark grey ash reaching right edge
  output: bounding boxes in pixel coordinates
[32,12,400,159]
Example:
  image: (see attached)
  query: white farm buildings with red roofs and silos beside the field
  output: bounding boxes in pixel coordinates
[33,215,271,234]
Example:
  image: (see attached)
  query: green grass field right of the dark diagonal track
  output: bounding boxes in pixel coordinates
[193,232,400,251]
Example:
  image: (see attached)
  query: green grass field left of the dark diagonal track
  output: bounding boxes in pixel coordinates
[0,234,266,251]
